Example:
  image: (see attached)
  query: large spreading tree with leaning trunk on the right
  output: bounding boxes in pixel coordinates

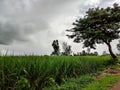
[67,3,120,63]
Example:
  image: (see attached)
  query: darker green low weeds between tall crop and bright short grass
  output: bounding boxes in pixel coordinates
[43,75,94,90]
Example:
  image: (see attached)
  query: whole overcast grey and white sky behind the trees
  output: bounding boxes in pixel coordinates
[0,0,120,55]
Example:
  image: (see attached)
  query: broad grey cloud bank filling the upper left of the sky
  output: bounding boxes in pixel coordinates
[0,0,81,44]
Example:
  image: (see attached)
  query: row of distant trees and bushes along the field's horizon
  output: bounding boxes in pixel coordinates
[51,40,98,56]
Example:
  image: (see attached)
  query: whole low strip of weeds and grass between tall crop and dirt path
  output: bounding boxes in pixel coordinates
[43,75,120,90]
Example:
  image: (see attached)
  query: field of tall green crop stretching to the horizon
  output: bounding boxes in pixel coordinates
[0,56,114,90]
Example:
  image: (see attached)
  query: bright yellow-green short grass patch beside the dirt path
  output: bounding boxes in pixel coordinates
[82,75,120,90]
